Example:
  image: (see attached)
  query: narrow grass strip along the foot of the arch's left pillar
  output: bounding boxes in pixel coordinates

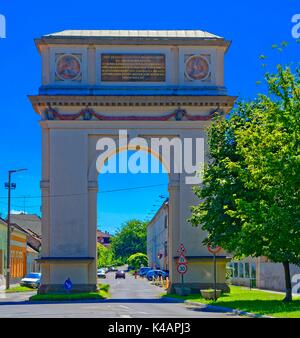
[30,284,109,301]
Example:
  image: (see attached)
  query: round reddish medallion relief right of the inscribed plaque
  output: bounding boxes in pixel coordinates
[185,55,210,81]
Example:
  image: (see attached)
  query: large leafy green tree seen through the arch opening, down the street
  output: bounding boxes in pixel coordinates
[111,220,147,263]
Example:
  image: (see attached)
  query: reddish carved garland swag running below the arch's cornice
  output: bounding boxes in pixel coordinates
[45,107,218,121]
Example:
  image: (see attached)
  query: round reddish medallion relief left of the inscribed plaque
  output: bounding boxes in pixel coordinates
[56,54,81,80]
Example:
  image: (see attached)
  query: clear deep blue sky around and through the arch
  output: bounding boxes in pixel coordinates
[0,0,300,231]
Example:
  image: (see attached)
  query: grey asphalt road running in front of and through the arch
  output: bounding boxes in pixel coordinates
[0,273,240,318]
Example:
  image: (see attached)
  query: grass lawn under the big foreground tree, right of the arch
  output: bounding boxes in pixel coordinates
[164,286,300,318]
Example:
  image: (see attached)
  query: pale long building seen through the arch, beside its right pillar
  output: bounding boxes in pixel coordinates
[147,200,169,270]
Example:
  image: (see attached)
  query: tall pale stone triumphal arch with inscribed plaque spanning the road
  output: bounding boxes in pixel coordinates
[30,30,235,293]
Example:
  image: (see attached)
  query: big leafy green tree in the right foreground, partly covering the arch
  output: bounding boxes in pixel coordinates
[190,66,300,301]
